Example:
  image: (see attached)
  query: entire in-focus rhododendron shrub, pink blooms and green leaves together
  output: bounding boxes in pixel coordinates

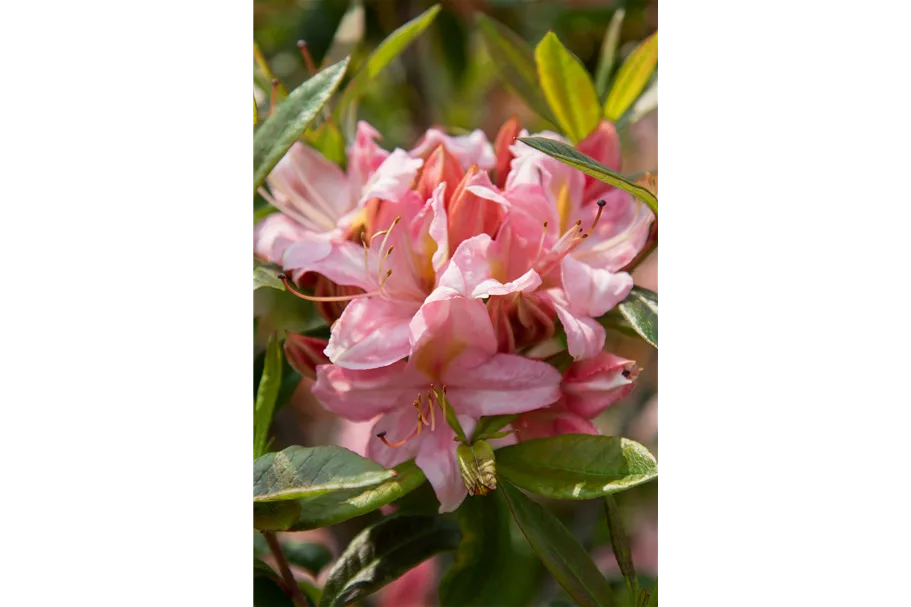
[252,7,657,605]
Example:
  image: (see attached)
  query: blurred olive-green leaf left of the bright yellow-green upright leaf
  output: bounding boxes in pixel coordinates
[477,14,557,124]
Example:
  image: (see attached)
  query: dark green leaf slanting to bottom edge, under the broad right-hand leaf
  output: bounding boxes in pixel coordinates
[500,482,611,607]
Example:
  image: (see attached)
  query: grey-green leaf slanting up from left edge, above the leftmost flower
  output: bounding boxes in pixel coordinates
[253,58,349,192]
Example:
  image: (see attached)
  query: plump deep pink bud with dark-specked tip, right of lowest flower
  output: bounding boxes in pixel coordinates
[560,352,639,419]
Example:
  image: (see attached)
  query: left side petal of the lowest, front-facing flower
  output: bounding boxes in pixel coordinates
[313,362,428,422]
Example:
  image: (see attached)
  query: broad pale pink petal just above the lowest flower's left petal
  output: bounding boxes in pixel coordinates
[325,297,418,369]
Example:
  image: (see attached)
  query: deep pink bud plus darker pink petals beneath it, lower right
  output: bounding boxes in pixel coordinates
[512,352,639,440]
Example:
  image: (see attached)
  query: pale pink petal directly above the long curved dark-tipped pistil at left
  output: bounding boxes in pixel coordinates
[282,241,379,292]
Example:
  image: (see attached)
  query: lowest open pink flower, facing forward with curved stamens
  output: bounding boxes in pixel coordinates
[313,295,560,513]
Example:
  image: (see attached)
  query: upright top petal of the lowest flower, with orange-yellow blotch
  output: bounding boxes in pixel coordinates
[408,297,497,381]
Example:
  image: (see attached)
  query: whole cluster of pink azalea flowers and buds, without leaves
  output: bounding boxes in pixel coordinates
[254,119,653,512]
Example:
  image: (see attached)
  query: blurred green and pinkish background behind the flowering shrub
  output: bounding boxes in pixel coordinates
[252,0,658,607]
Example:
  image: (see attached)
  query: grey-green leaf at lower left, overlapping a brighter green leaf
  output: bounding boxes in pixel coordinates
[253,444,395,503]
